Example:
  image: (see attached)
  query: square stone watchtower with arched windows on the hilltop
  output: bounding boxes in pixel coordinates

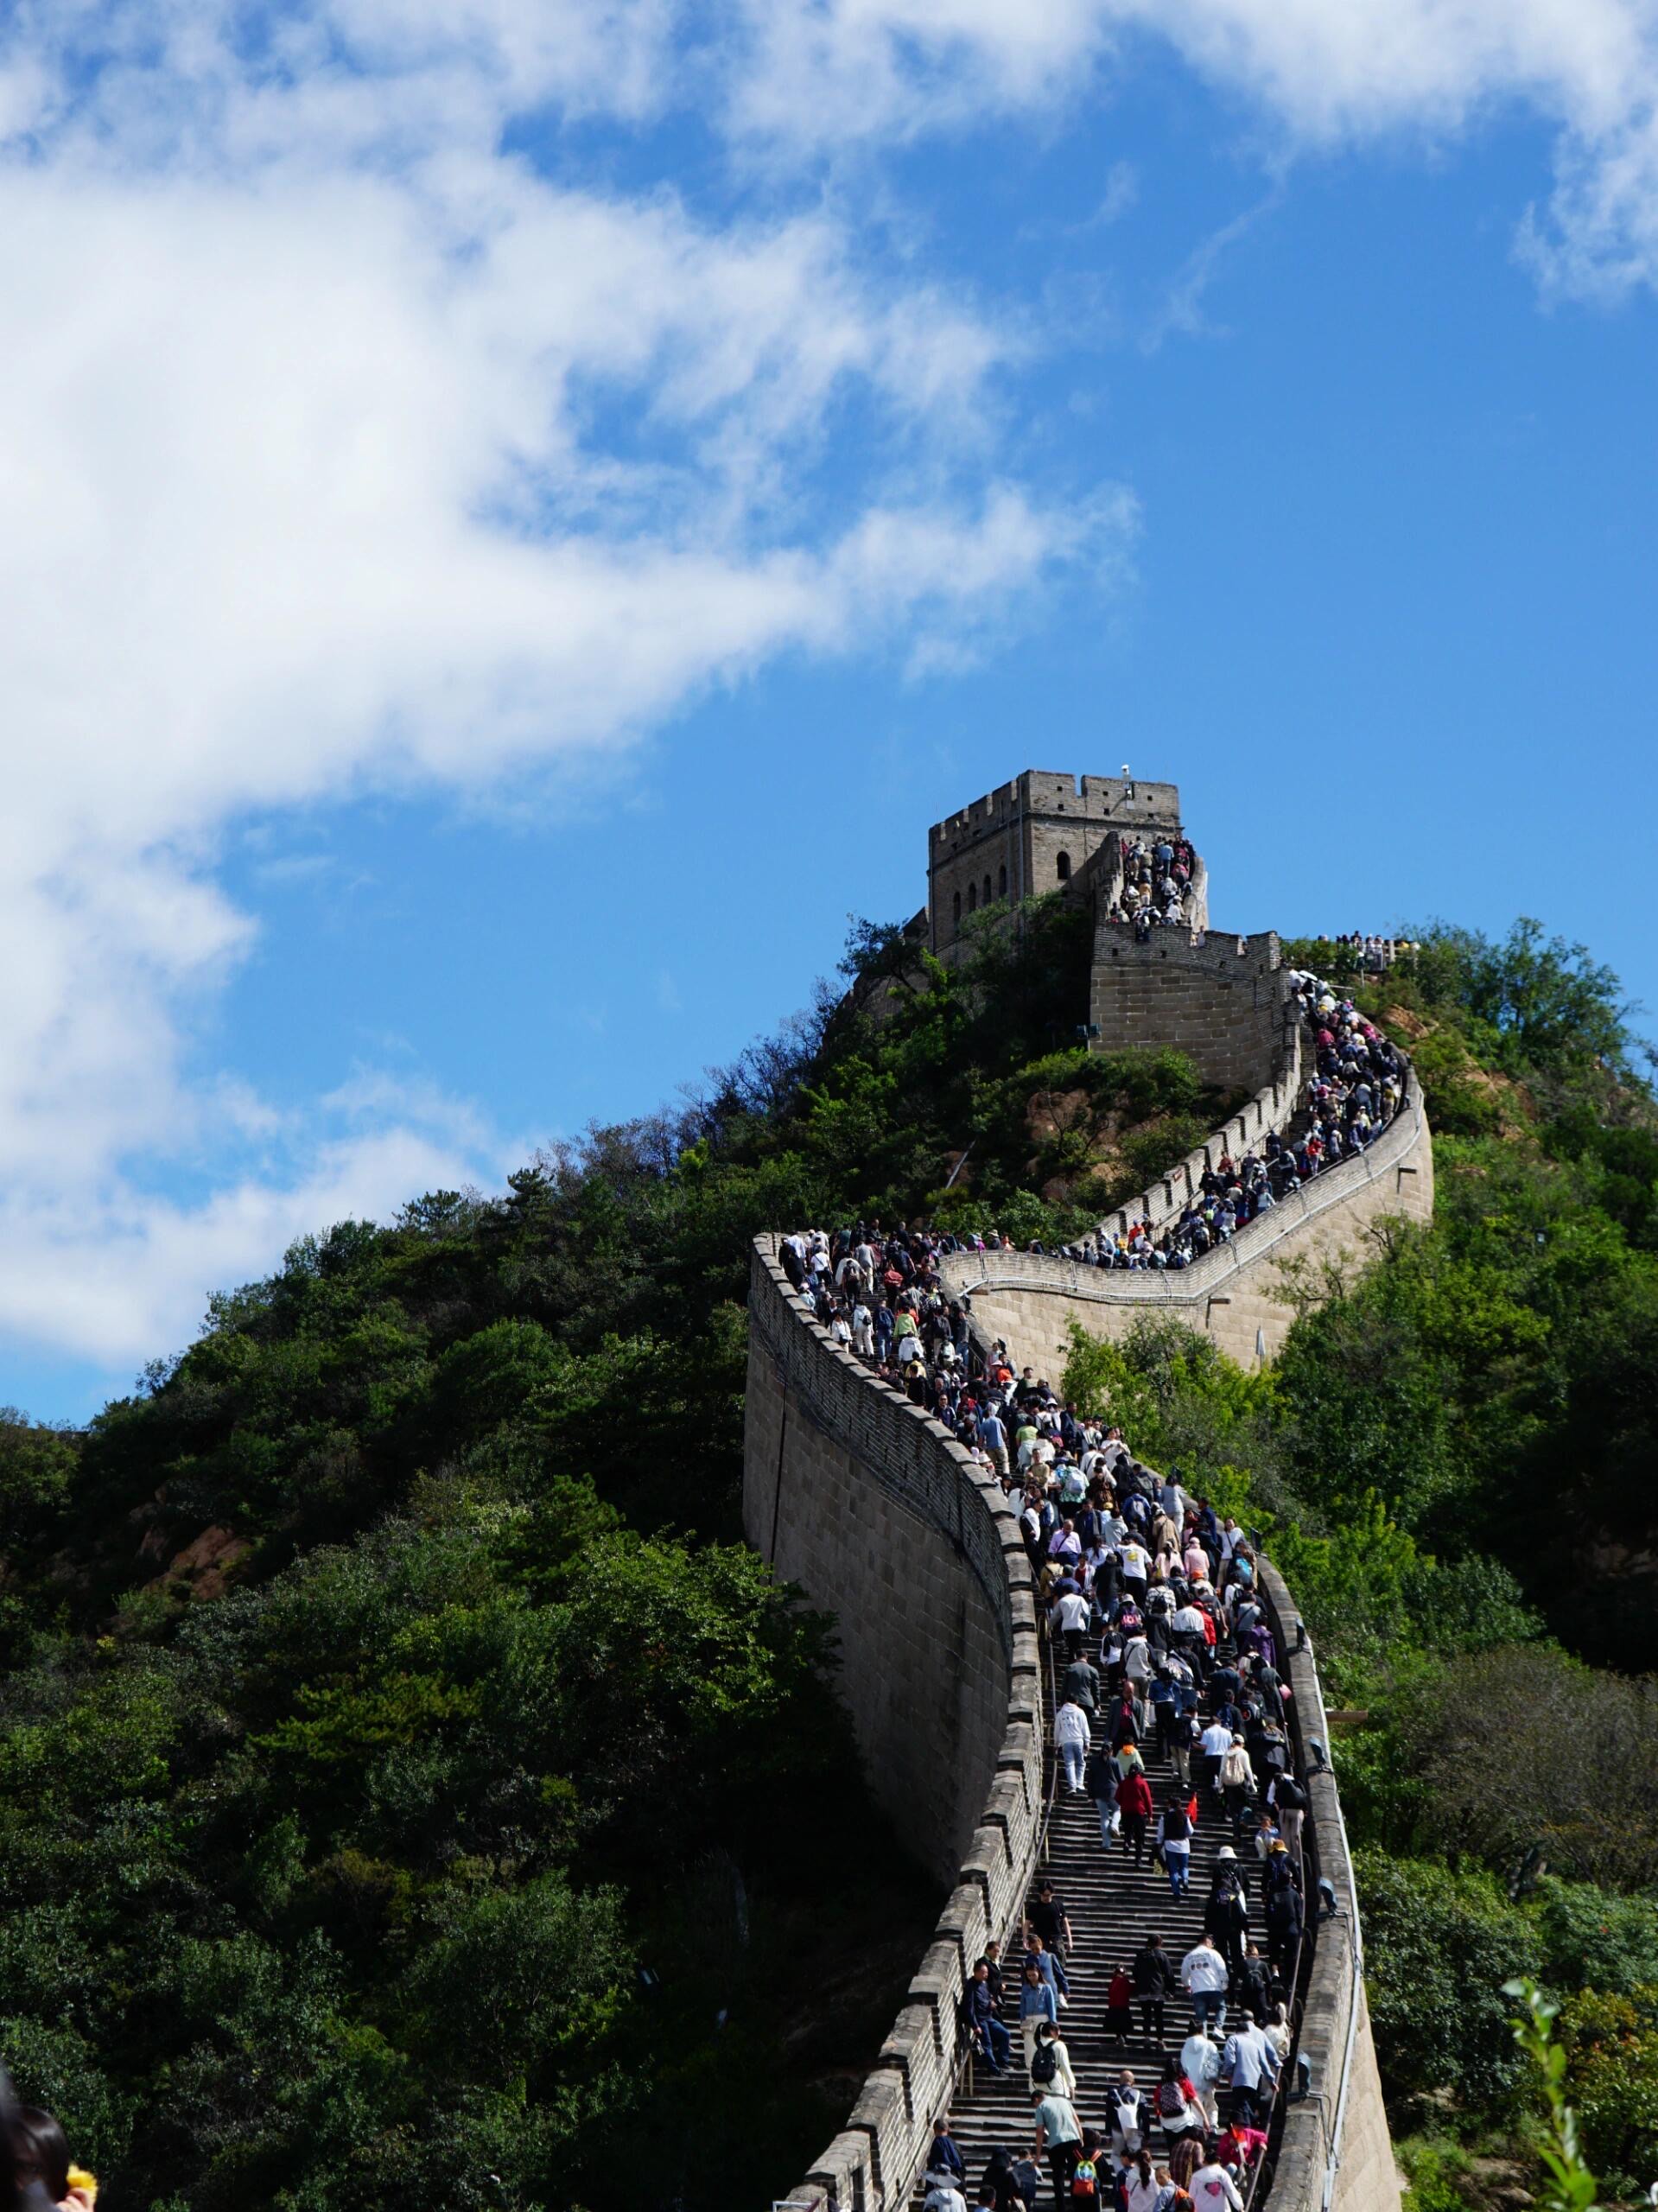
[926,767,1180,960]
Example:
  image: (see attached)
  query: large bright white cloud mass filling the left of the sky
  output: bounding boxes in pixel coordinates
[0,0,1140,1358]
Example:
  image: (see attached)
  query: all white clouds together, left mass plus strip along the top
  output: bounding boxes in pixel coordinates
[0,0,1658,1358]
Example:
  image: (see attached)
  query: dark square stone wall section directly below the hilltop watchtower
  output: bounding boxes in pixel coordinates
[1088,919,1295,1090]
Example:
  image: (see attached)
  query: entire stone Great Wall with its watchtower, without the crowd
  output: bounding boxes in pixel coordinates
[743,772,1432,2212]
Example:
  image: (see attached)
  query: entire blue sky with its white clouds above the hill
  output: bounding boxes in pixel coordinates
[0,0,1658,1418]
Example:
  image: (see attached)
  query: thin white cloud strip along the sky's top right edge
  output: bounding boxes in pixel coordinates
[727,0,1658,296]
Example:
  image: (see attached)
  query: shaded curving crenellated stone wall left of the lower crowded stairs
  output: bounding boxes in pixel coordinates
[743,1236,1044,2212]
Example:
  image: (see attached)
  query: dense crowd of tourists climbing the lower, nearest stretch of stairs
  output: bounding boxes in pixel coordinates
[780,1230,1308,2212]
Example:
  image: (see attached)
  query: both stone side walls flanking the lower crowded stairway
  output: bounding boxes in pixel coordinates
[743,1236,1400,2212]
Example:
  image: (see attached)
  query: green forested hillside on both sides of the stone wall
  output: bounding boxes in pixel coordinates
[0,900,1658,2212]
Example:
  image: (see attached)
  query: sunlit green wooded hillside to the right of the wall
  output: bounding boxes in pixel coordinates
[1065,923,1658,2212]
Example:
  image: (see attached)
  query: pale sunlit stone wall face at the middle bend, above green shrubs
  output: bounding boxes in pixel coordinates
[942,1075,1432,1385]
